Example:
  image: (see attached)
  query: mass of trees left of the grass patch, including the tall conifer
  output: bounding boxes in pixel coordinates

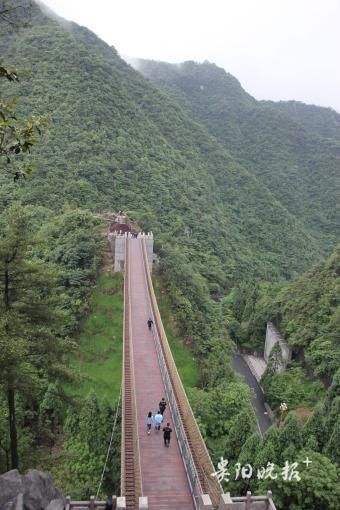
[0,203,100,470]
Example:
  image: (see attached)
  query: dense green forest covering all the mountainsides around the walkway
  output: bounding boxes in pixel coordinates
[0,1,340,510]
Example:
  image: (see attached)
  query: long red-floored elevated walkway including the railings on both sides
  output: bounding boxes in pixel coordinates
[121,236,222,510]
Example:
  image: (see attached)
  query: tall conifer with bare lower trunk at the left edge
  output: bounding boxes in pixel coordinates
[0,205,67,468]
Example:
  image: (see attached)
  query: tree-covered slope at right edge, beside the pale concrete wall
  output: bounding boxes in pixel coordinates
[277,247,340,379]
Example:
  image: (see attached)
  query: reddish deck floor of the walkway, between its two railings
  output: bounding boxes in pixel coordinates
[127,239,194,510]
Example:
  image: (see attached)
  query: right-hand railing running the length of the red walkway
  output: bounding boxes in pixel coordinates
[142,239,222,507]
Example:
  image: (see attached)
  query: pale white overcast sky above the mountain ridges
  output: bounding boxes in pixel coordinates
[44,0,340,112]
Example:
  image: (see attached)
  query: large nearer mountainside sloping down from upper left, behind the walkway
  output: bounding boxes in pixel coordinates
[0,0,320,293]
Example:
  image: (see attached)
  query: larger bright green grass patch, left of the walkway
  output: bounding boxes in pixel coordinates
[71,273,123,404]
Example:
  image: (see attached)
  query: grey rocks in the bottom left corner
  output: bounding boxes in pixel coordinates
[0,469,65,510]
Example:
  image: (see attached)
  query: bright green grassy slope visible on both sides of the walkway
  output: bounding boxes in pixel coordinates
[71,273,199,403]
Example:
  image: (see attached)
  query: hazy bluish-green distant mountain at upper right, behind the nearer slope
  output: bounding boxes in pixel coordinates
[137,60,340,251]
